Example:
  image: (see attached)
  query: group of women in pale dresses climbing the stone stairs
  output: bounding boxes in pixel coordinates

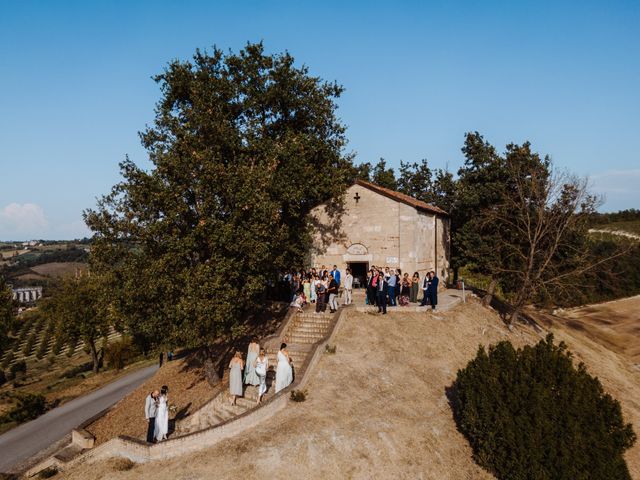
[229,339,293,405]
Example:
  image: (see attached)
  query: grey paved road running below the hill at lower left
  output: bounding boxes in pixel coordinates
[0,365,158,472]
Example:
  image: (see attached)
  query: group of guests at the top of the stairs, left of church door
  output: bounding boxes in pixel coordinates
[283,265,353,313]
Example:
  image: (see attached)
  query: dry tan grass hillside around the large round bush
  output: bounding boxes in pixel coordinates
[57,303,640,480]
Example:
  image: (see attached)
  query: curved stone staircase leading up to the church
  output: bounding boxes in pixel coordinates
[174,305,337,436]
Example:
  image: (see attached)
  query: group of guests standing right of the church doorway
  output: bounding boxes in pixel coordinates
[366,266,439,314]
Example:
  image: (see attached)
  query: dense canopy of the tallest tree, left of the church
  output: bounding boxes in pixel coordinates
[85,44,353,346]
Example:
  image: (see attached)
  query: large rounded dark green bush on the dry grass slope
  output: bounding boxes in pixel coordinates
[452,335,636,480]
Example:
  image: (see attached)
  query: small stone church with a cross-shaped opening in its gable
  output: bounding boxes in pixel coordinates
[311,180,450,282]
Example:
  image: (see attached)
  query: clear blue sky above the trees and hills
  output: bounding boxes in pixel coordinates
[0,0,640,240]
